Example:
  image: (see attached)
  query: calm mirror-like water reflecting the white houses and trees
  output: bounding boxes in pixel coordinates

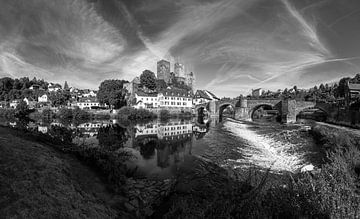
[0,115,212,178]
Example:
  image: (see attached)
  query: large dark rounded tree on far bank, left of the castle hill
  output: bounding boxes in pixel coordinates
[97,80,127,109]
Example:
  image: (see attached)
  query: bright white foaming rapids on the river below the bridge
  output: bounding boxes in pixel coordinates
[224,121,305,172]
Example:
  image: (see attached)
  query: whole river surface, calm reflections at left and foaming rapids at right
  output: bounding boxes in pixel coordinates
[2,118,320,179]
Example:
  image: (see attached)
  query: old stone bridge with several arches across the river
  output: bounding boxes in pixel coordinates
[195,98,318,123]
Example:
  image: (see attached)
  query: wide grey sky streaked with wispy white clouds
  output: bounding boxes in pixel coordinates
[0,0,360,97]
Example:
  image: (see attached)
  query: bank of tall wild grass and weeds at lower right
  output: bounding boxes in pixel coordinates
[158,125,360,218]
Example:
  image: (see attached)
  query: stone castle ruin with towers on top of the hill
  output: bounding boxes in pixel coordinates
[157,60,195,90]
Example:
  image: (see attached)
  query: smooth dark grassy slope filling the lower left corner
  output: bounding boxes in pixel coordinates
[0,127,117,218]
